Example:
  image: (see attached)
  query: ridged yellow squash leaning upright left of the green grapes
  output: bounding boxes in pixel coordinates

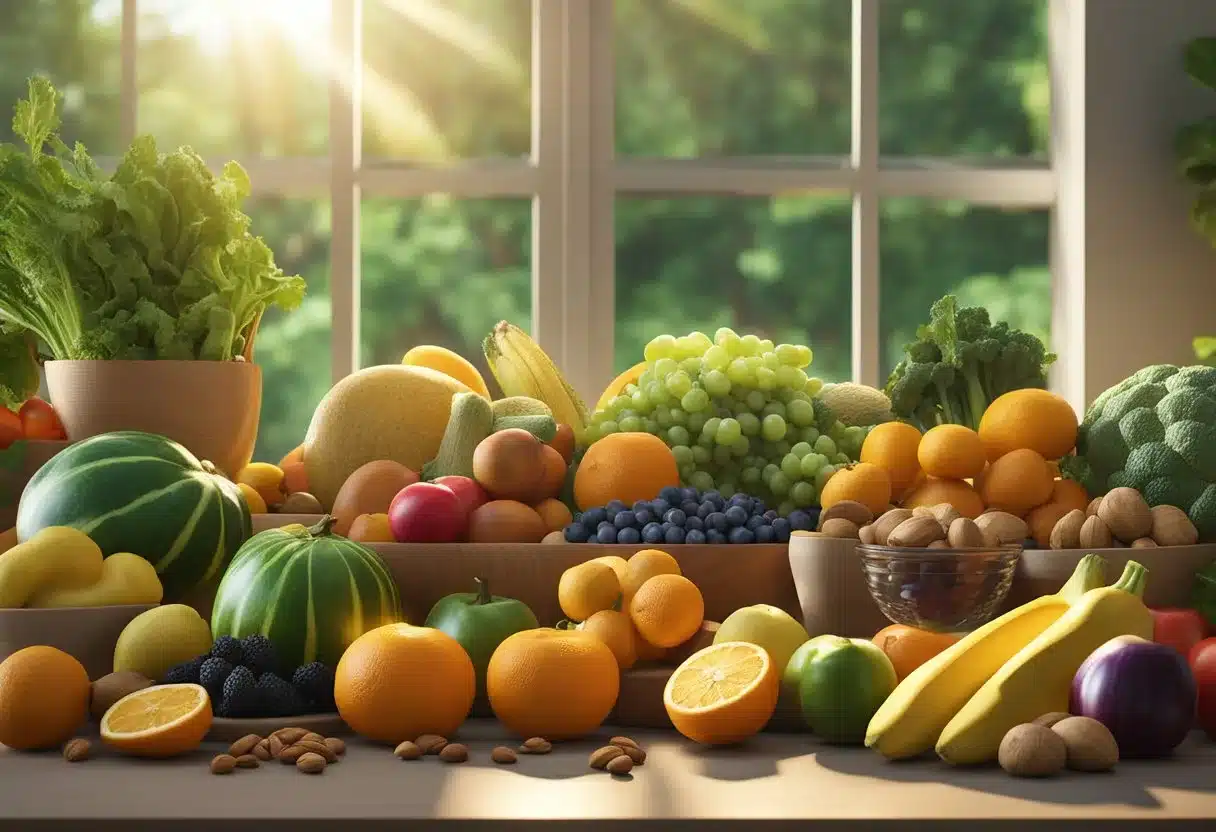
[482,321,587,437]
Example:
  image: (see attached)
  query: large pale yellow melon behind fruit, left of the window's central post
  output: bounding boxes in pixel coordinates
[304,364,471,508]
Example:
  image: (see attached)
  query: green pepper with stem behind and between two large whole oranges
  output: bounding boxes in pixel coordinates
[426,578,540,696]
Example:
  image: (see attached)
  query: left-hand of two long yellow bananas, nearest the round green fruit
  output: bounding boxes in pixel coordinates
[866,555,1105,759]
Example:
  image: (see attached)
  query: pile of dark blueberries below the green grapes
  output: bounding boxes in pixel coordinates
[564,487,818,545]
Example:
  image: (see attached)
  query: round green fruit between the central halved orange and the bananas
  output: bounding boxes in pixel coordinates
[787,635,897,744]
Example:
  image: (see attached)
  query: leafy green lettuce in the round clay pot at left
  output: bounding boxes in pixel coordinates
[0,78,304,397]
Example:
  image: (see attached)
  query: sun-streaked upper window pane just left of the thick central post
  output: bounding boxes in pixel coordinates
[364,0,531,162]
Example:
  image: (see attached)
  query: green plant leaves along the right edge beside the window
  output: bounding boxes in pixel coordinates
[1176,38,1216,364]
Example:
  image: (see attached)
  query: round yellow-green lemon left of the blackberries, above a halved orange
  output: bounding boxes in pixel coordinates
[114,603,212,680]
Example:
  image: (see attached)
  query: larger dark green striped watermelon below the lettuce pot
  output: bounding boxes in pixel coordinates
[17,431,253,603]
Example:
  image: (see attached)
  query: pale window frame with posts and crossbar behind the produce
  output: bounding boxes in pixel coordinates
[111,0,1086,407]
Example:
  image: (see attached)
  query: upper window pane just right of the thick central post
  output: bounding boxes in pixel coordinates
[615,0,851,157]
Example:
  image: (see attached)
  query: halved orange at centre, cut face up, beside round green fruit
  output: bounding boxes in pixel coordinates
[663,641,781,746]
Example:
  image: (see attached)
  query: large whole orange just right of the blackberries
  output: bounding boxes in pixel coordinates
[333,624,477,744]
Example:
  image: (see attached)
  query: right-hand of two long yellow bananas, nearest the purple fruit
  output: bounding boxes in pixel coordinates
[938,561,1153,765]
